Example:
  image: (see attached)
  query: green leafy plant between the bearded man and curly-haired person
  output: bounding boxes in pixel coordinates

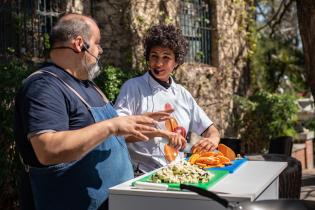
[95,66,139,101]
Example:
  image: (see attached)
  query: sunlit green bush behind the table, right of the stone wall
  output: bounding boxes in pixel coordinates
[235,91,298,152]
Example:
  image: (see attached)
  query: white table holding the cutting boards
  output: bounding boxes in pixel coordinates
[109,161,287,210]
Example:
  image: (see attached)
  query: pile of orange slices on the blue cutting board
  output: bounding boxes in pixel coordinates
[189,144,236,169]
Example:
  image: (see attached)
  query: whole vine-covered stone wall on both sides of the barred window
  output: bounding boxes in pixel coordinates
[92,0,247,136]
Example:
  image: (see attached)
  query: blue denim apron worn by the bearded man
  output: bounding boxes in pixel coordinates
[24,71,134,210]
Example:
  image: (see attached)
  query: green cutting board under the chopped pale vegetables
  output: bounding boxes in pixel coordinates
[132,171,229,190]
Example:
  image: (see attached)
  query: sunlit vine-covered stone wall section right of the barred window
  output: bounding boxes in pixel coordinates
[176,0,247,137]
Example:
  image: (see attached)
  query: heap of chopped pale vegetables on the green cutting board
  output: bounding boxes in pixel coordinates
[149,160,214,184]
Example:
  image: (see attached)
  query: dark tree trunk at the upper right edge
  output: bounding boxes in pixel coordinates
[296,0,315,101]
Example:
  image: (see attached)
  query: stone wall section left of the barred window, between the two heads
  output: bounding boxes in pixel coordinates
[92,0,179,69]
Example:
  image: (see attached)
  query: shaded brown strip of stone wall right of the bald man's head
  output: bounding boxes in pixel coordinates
[92,0,133,69]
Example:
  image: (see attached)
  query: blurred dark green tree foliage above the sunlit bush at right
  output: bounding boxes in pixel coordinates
[250,35,307,94]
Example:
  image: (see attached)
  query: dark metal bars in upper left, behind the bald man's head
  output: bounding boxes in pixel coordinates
[0,0,66,57]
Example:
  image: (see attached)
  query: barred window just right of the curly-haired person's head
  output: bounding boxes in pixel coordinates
[180,0,211,64]
